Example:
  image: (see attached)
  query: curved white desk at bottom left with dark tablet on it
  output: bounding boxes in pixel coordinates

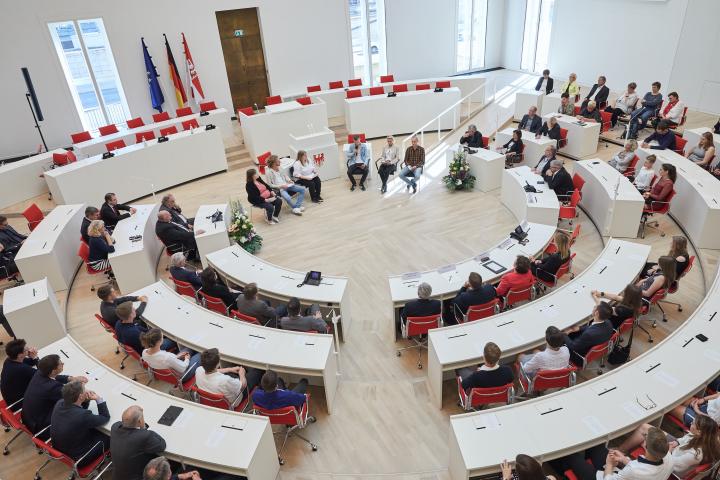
[40,336,279,480]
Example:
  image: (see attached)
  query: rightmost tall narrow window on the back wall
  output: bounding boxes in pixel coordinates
[520,0,555,72]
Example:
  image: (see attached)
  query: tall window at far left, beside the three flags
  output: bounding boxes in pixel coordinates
[48,18,130,130]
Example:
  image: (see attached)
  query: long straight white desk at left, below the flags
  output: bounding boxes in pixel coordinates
[45,128,227,205]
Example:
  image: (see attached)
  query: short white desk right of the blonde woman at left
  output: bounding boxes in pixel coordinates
[108,203,163,292]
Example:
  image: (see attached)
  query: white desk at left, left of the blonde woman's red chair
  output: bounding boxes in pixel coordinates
[15,203,84,292]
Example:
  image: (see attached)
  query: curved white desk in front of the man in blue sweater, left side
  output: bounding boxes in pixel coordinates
[131,282,338,412]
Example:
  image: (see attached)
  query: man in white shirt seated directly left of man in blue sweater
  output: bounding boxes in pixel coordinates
[195,348,263,410]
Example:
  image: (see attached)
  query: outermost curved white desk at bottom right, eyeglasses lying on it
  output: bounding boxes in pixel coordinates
[450,256,720,479]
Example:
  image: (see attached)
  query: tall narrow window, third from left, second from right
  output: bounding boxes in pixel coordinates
[455,0,487,73]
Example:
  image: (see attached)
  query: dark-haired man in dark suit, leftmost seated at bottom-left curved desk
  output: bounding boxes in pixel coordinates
[0,338,38,411]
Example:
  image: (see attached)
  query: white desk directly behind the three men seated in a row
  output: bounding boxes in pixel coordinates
[345,87,460,138]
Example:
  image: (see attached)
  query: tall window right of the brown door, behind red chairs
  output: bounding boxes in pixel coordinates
[348,0,387,85]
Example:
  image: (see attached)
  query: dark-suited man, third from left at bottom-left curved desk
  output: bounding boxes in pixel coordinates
[50,382,110,467]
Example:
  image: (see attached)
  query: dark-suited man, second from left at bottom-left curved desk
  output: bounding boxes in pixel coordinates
[22,354,87,433]
